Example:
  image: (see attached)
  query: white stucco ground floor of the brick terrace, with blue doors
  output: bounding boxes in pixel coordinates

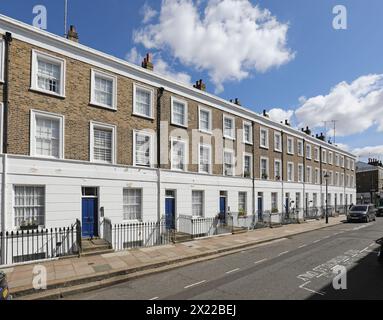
[0,155,356,232]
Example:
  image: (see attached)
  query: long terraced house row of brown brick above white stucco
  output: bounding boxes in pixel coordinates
[0,16,356,237]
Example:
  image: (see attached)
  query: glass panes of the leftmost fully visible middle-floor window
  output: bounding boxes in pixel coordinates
[35,116,60,158]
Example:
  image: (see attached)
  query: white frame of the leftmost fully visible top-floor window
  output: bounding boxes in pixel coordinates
[31,49,66,98]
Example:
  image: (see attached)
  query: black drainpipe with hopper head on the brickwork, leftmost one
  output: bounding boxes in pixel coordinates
[2,32,12,153]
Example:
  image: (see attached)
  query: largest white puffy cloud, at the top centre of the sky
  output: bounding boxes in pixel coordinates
[133,0,294,92]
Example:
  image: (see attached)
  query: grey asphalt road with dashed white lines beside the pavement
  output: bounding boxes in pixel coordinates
[67,218,383,300]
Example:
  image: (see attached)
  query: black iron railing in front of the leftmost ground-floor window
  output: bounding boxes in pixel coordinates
[0,221,81,265]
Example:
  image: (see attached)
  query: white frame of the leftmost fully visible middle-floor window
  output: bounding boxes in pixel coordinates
[30,109,65,159]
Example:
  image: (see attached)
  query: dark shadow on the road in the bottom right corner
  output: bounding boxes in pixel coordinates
[307,252,383,300]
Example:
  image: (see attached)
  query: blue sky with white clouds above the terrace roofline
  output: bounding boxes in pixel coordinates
[0,0,383,160]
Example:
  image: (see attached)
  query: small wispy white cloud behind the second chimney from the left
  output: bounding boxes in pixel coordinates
[125,47,192,85]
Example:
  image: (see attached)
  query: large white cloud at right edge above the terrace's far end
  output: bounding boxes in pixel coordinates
[295,74,383,136]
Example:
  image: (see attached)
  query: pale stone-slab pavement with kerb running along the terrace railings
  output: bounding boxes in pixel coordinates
[3,216,344,299]
